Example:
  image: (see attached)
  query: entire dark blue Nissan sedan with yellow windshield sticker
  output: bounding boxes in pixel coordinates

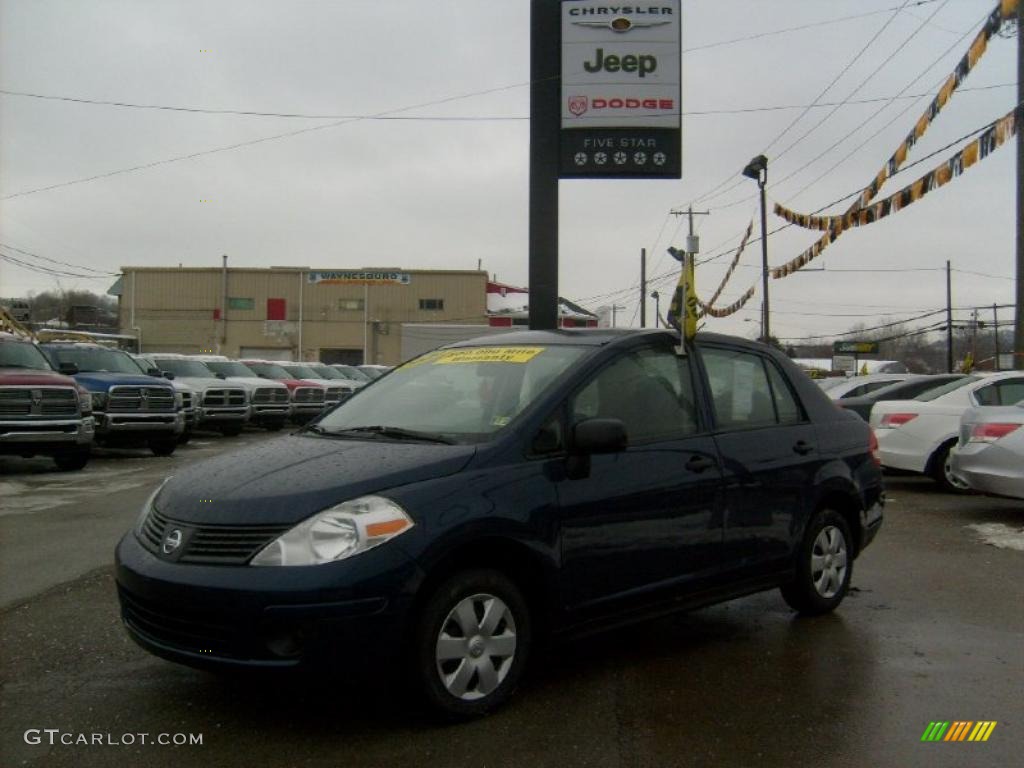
[117,331,884,717]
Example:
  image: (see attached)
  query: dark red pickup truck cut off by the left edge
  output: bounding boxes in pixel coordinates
[0,333,95,470]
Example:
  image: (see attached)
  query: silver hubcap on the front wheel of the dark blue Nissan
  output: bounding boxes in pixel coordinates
[435,594,516,701]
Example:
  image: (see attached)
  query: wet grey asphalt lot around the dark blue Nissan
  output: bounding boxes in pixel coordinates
[0,432,1024,768]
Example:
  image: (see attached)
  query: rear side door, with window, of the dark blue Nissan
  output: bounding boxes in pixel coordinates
[699,344,821,575]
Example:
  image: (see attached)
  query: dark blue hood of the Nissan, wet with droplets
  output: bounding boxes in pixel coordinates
[156,434,476,525]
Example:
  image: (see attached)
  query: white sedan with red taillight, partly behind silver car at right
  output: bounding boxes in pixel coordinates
[870,371,1024,490]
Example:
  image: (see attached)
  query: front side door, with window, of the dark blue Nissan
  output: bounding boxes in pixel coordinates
[558,345,722,616]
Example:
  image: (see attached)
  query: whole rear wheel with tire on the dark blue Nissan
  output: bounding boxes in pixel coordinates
[781,509,853,615]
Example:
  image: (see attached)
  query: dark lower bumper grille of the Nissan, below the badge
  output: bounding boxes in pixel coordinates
[118,586,274,659]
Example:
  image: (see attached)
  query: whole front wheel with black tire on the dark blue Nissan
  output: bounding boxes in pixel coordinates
[412,569,532,720]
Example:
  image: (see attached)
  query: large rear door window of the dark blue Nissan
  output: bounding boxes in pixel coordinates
[701,348,774,429]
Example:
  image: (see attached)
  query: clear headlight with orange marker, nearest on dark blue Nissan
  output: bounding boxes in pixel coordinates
[252,496,413,565]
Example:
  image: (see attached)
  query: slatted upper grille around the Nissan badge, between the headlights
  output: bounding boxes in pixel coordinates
[142,510,291,565]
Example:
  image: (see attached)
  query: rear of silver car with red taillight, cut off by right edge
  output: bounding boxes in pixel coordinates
[952,400,1024,499]
